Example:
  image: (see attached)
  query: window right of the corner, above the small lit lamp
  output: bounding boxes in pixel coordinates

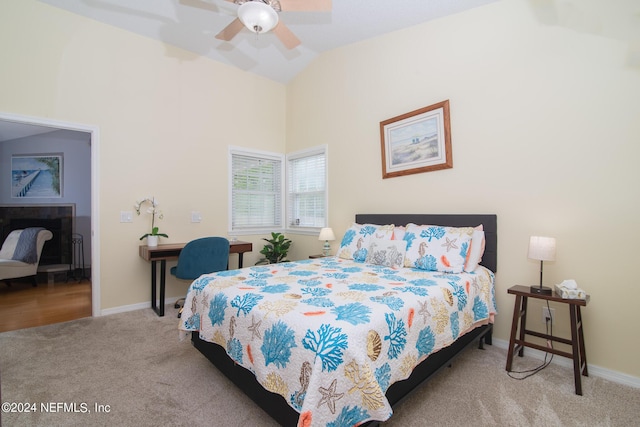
[287,146,327,232]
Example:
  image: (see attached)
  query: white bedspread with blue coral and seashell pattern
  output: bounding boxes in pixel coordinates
[180,257,495,426]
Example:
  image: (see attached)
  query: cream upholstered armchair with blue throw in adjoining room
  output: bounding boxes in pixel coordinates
[0,227,53,286]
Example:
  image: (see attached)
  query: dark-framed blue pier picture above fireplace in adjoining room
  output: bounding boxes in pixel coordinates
[11,154,62,198]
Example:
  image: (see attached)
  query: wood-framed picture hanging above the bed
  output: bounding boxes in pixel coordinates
[380,100,453,179]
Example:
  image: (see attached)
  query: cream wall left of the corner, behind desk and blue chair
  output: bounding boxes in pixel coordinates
[0,0,286,310]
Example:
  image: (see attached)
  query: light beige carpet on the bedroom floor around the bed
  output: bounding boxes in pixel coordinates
[0,306,640,427]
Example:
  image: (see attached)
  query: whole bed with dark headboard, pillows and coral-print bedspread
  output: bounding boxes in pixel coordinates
[180,214,497,426]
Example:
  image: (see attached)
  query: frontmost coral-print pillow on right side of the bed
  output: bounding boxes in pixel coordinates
[404,224,473,273]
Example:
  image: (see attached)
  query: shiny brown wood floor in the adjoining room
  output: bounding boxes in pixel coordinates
[0,279,91,332]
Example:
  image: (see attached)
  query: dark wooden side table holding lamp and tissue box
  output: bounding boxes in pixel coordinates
[506,286,589,396]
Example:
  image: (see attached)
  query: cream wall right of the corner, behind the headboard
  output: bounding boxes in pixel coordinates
[287,1,640,377]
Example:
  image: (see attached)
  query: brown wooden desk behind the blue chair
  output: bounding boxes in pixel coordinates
[138,241,253,316]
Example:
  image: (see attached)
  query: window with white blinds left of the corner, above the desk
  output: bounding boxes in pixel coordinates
[229,147,284,233]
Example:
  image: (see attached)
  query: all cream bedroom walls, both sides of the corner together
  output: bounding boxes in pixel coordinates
[0,0,640,377]
